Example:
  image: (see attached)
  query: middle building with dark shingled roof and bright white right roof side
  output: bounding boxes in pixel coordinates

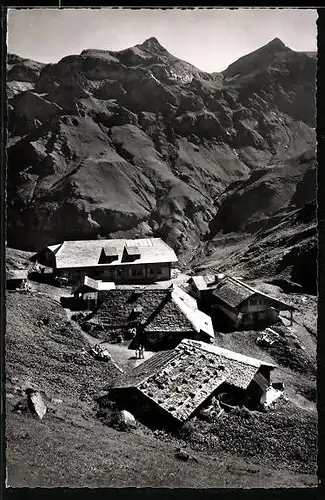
[88,286,214,349]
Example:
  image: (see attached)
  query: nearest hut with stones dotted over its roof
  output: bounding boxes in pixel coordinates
[102,339,279,423]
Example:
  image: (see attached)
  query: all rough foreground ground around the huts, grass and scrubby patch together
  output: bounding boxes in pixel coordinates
[6,250,317,488]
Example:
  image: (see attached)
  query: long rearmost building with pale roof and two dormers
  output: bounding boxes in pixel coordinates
[33,238,177,283]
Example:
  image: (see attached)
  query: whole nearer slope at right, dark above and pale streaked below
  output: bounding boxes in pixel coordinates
[189,152,317,294]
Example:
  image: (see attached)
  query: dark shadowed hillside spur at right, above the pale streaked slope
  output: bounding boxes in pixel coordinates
[210,151,316,237]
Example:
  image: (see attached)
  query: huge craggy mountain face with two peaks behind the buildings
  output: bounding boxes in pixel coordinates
[7,38,316,252]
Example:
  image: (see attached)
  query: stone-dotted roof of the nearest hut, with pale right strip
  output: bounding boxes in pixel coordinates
[113,339,275,422]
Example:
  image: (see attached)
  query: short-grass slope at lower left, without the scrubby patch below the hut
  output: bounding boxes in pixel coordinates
[6,287,315,487]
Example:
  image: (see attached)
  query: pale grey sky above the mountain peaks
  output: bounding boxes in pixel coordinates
[7,8,317,72]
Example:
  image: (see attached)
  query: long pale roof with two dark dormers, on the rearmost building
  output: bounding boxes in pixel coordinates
[51,238,177,269]
